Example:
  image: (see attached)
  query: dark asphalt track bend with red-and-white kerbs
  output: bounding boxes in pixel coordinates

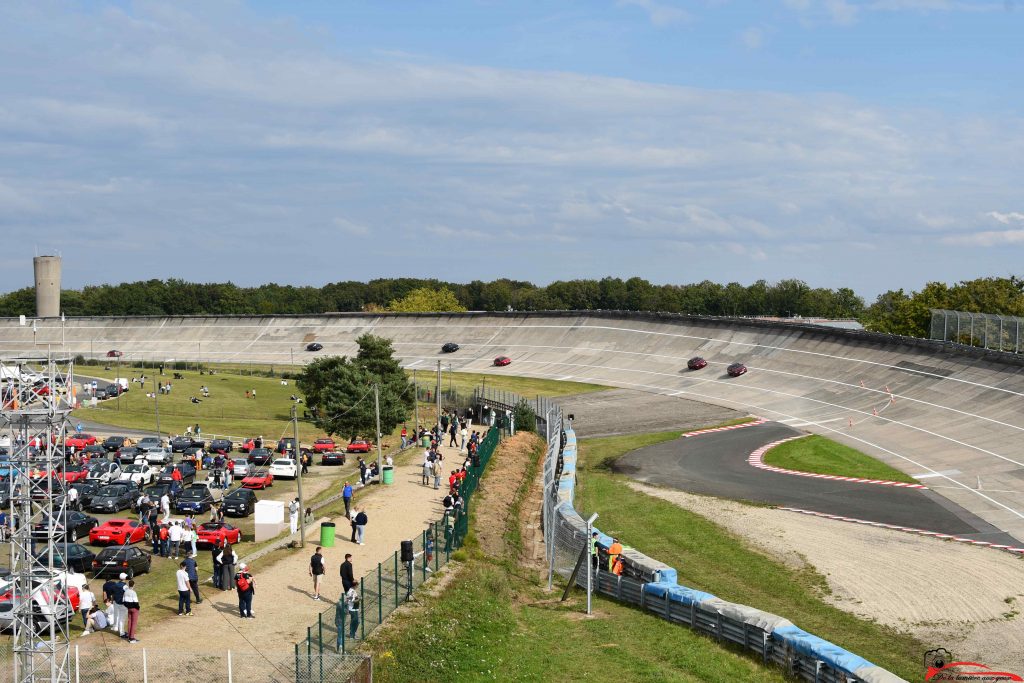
[613,422,1017,545]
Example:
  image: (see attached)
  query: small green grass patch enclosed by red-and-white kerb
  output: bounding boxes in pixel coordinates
[765,434,918,483]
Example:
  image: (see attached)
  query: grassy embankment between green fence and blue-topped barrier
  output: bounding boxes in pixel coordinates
[369,436,786,683]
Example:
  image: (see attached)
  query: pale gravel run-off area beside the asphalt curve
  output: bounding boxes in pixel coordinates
[630,483,1024,674]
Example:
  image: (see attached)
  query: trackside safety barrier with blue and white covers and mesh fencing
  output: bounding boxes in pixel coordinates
[543,395,903,683]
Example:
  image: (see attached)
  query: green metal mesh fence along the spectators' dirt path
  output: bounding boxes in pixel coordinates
[295,429,501,659]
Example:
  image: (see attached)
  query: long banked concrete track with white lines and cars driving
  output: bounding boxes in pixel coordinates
[0,312,1024,541]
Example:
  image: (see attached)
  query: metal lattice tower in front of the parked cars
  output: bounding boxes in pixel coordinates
[0,357,75,683]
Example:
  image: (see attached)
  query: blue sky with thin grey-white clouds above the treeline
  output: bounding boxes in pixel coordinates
[0,0,1024,298]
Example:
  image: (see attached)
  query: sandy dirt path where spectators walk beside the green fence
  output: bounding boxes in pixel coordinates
[76,438,465,658]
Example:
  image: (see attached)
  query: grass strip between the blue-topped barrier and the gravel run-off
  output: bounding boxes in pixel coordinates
[577,432,927,680]
